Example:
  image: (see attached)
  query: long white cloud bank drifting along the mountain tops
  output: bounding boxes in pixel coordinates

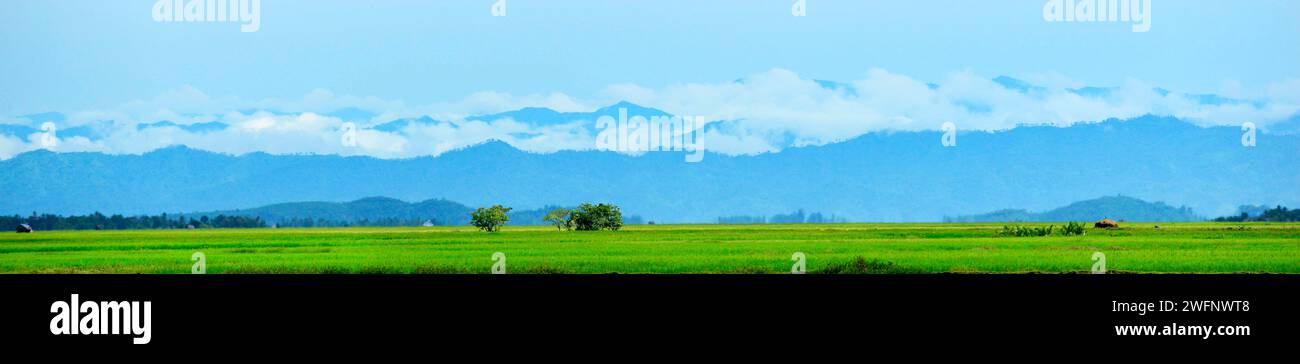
[0,69,1300,159]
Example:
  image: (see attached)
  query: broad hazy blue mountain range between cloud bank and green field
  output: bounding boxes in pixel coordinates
[0,117,1300,222]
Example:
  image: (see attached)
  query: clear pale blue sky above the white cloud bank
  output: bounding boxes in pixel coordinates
[0,0,1300,116]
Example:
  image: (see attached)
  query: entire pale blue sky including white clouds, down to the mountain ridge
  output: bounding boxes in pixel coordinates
[0,0,1300,159]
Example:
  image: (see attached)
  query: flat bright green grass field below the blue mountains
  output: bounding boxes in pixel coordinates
[0,222,1300,274]
